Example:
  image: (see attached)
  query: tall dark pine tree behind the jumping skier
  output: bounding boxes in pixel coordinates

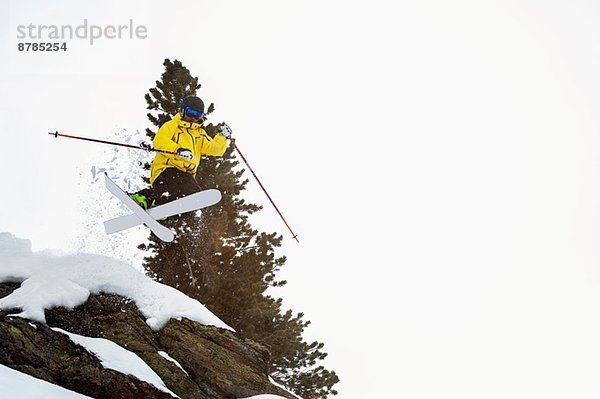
[140,59,338,399]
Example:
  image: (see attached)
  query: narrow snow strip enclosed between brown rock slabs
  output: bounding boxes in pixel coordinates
[53,328,179,398]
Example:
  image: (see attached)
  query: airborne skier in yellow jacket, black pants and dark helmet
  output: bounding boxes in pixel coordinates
[130,96,231,209]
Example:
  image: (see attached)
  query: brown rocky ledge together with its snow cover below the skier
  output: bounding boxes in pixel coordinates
[0,233,295,399]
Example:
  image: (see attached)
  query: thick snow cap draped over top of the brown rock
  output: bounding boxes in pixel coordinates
[0,233,234,331]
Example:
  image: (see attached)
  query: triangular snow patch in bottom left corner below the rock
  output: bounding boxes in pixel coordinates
[0,364,91,399]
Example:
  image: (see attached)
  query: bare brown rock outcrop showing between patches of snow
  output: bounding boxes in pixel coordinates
[0,283,293,399]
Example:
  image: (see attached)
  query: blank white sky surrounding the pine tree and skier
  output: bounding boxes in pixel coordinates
[0,0,600,399]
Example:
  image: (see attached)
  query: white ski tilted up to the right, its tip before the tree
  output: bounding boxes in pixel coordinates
[104,189,221,234]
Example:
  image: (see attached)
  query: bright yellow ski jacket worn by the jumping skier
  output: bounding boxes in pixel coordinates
[150,114,227,184]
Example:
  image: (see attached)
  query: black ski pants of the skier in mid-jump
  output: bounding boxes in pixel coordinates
[138,168,201,207]
